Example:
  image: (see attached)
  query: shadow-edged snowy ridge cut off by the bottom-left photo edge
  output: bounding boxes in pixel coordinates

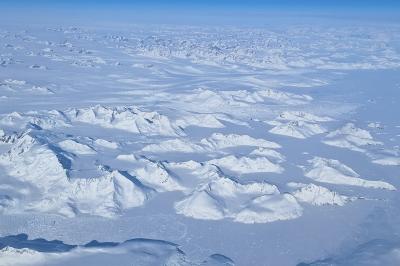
[0,236,234,266]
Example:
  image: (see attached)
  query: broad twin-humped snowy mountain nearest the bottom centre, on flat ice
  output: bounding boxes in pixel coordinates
[175,177,302,223]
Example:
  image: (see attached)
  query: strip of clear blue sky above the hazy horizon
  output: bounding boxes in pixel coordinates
[0,0,400,24]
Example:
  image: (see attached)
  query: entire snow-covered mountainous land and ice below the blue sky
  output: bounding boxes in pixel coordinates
[0,19,400,265]
